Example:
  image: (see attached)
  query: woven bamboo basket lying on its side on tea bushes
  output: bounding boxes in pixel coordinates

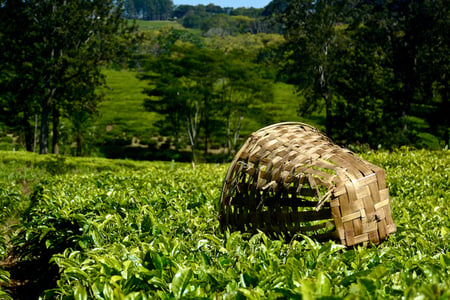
[219,122,396,246]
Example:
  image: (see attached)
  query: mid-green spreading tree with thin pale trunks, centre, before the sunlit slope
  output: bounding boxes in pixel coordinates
[140,41,272,161]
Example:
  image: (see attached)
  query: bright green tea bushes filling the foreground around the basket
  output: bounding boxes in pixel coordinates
[0,149,450,299]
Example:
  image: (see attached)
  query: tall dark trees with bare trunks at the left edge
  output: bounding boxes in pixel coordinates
[0,0,137,153]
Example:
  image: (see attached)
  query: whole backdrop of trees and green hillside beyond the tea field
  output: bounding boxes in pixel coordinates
[0,0,450,161]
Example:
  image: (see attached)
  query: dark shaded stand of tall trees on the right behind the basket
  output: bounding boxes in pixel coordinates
[280,0,450,148]
